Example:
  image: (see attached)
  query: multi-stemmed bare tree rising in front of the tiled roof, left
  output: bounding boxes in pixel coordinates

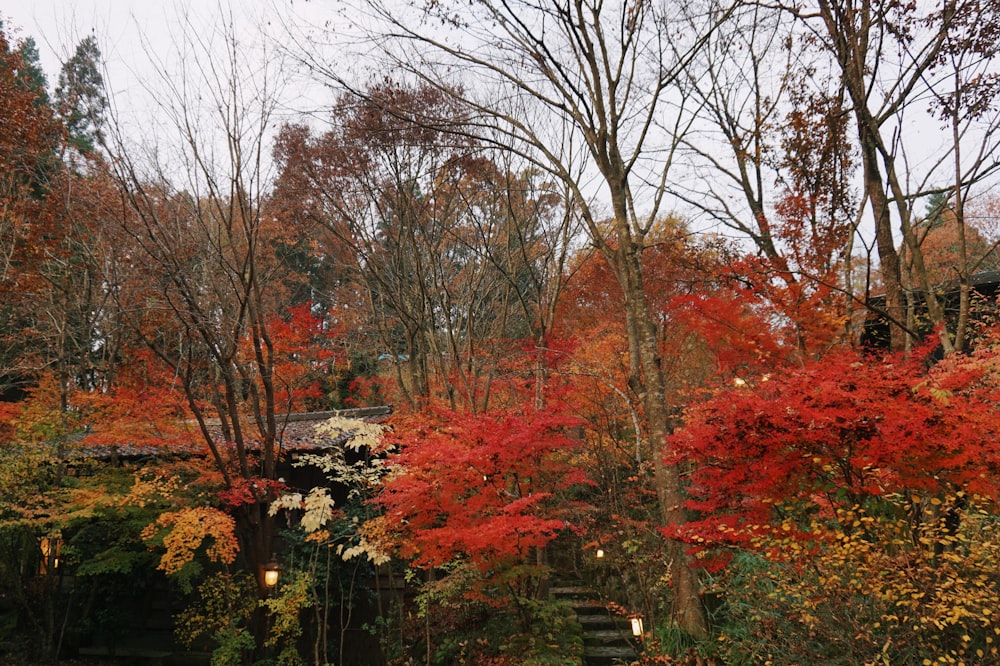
[99,6,287,612]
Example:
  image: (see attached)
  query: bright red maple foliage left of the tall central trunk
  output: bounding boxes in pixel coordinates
[377,402,587,570]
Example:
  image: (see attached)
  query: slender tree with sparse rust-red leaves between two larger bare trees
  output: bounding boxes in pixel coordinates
[672,4,855,353]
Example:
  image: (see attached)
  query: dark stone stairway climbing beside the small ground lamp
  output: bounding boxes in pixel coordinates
[549,583,638,666]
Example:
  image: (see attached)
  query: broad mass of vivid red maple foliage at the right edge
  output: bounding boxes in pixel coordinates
[668,342,1000,556]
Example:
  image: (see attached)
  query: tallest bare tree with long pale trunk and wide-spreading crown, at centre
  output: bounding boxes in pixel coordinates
[292,0,730,635]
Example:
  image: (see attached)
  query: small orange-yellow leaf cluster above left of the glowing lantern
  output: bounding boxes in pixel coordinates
[142,506,239,574]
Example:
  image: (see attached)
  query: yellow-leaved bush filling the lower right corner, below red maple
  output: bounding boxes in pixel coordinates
[724,496,1000,664]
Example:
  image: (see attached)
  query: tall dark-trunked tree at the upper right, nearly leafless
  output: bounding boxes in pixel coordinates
[793,0,998,352]
